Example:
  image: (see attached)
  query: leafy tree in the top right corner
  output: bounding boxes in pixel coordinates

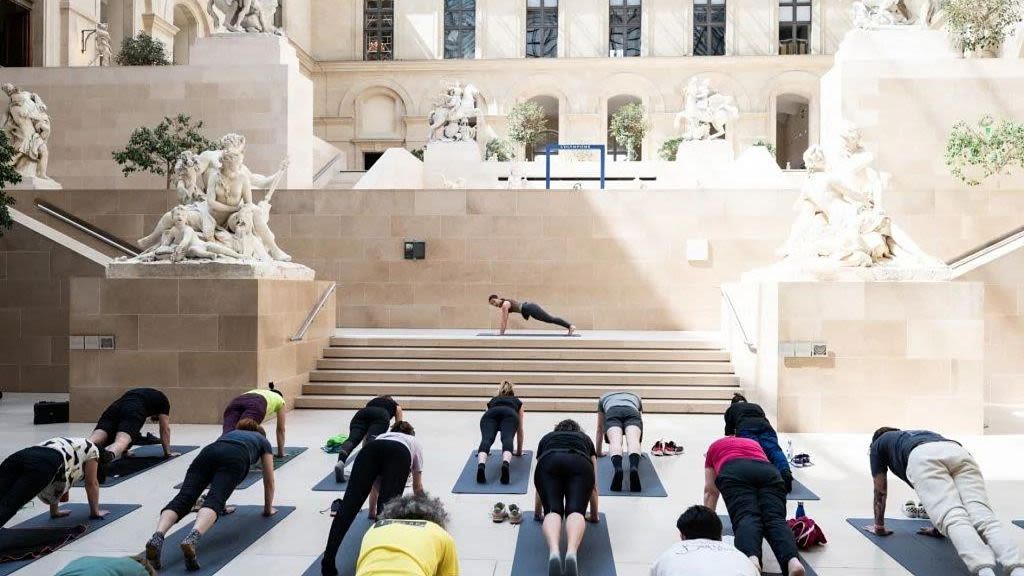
[942,0,1024,53]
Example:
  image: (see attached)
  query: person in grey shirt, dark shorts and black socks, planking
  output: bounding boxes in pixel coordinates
[594,392,643,492]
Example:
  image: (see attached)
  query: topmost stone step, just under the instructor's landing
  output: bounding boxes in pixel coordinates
[324,345,729,362]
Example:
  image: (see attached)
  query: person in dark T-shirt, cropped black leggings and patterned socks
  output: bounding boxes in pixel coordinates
[145,418,278,571]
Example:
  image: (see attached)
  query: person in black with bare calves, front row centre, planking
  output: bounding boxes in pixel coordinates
[534,420,599,576]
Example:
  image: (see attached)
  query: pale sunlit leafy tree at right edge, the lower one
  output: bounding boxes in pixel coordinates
[946,116,1024,187]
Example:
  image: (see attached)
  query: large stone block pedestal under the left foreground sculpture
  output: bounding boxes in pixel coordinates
[69,266,336,424]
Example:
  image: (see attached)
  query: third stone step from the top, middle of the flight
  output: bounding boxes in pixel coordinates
[309,370,738,386]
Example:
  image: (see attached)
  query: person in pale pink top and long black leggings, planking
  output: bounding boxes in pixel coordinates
[321,421,424,576]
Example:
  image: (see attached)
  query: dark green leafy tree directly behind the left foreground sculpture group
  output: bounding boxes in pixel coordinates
[114,114,217,188]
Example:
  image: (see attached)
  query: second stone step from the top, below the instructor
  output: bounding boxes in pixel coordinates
[316,358,732,374]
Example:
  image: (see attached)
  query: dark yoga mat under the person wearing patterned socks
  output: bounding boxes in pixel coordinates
[160,505,295,576]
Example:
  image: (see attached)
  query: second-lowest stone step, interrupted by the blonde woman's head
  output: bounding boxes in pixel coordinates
[303,382,739,399]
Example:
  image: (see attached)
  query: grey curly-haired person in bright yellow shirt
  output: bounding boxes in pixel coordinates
[355,487,459,576]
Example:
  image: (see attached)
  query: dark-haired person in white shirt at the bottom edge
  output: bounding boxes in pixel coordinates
[650,506,760,576]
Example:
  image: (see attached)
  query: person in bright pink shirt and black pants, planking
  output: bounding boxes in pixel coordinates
[705,437,806,576]
